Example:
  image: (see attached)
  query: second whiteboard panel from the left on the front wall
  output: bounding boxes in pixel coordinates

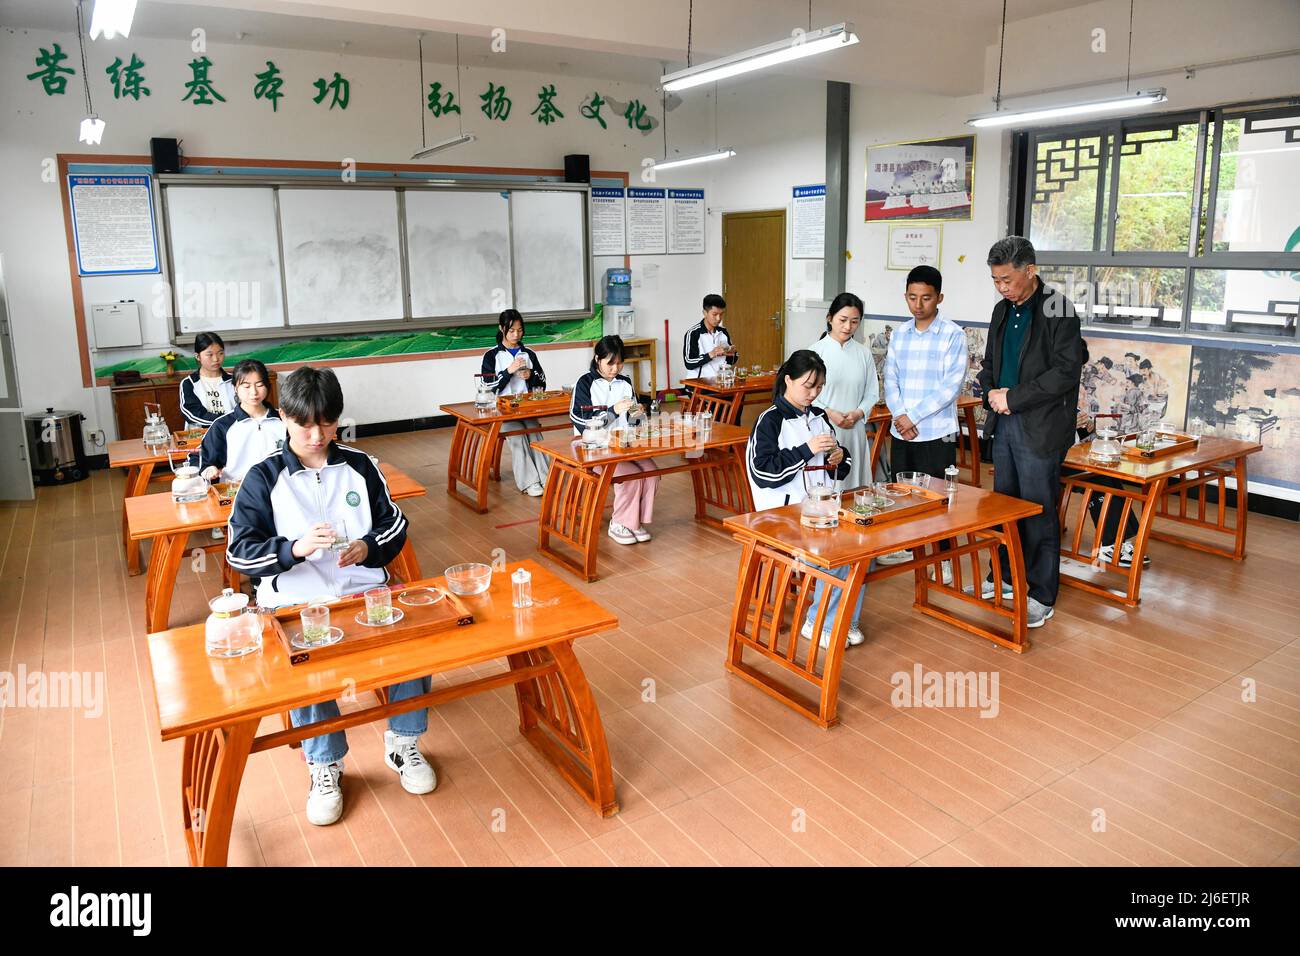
[280,187,406,325]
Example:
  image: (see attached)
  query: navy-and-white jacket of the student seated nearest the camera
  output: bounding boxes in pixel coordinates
[226,442,407,607]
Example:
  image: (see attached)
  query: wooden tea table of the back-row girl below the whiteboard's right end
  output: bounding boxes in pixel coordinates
[439,394,573,514]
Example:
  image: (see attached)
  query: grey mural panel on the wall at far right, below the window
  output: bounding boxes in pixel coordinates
[1187,346,1300,488]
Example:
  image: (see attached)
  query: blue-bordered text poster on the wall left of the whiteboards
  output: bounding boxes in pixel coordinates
[68,174,159,276]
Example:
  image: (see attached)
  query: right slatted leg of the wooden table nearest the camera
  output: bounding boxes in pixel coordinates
[510,641,619,817]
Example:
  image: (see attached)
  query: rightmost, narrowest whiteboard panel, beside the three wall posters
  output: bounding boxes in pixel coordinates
[510,190,588,313]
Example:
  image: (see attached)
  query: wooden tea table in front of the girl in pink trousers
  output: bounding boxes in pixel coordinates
[533,424,754,581]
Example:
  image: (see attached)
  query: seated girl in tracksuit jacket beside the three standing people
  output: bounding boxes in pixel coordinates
[745,349,867,648]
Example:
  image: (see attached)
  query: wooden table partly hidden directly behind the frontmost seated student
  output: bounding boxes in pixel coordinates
[125,462,425,633]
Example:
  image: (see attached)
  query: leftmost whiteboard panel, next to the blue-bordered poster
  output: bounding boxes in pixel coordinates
[165,186,285,332]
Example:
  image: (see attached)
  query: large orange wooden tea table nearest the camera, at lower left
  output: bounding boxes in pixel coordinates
[148,561,619,866]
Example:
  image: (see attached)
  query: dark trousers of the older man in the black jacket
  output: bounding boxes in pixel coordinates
[993,415,1060,607]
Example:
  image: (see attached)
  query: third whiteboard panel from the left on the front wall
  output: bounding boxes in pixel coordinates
[406,190,514,319]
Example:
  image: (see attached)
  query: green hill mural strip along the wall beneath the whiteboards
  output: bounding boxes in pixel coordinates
[95,304,603,378]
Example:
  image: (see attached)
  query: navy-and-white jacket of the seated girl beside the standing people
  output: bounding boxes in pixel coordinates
[745,397,853,511]
